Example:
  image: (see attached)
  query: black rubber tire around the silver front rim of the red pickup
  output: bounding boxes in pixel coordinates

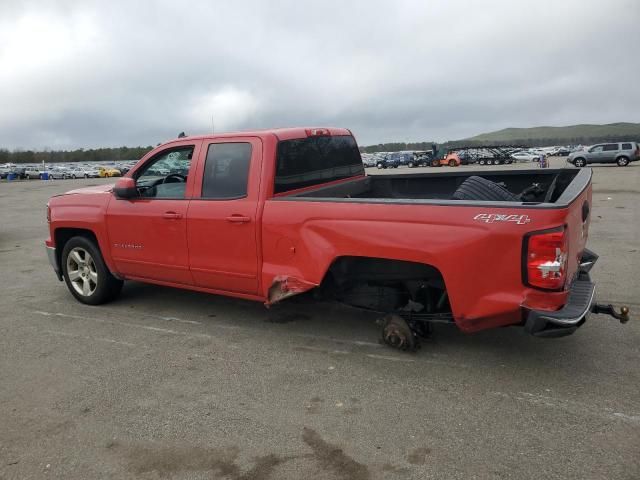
[60,237,124,305]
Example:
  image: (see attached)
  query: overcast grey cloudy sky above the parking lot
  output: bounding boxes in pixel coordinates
[0,0,640,149]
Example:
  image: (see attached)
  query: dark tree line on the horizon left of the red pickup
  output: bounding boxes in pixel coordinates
[0,146,154,164]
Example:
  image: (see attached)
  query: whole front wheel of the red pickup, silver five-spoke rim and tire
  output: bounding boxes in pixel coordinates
[61,237,123,305]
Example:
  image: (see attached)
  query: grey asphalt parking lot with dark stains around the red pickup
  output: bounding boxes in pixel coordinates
[0,159,640,480]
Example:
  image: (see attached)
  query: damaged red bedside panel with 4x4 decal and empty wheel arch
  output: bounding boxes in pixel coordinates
[262,200,566,332]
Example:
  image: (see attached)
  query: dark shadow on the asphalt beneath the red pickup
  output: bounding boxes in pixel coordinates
[114,282,600,370]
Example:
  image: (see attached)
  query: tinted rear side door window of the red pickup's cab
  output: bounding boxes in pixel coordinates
[202,142,251,199]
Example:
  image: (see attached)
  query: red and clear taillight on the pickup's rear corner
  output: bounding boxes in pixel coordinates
[522,227,568,290]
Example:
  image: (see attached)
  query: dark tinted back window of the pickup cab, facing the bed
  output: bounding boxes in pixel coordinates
[274,135,364,194]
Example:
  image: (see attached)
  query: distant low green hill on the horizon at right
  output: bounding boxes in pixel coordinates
[464,122,640,145]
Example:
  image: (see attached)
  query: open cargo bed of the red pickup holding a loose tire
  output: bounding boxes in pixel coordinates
[278,169,591,207]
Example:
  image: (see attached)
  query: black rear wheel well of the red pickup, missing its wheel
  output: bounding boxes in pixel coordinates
[321,256,451,312]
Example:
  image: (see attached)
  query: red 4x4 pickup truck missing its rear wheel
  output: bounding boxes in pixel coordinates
[46,128,628,348]
